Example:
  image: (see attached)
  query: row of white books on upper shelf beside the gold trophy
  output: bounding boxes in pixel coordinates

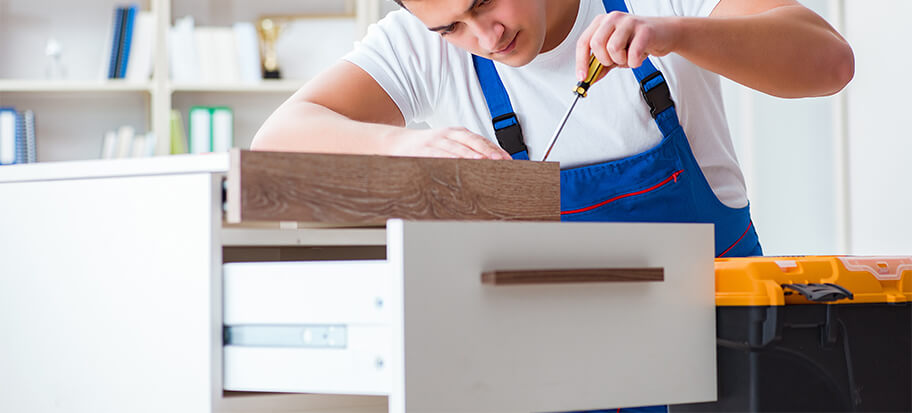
[168,16,263,84]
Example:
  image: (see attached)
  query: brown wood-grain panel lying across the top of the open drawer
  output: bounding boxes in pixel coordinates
[227,150,560,226]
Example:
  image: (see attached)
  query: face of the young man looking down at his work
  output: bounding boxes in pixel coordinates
[403,0,547,66]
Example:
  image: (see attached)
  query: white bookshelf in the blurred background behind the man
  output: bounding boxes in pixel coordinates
[0,0,397,162]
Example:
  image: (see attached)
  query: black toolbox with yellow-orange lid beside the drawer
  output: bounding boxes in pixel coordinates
[670,256,912,412]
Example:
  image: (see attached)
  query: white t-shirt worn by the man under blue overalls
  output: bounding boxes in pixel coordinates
[344,0,747,208]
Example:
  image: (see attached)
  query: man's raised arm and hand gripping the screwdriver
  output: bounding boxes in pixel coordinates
[577,0,855,98]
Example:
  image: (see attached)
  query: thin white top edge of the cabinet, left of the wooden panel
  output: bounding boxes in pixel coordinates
[0,154,229,183]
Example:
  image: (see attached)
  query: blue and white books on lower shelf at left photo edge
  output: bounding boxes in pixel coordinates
[0,107,37,165]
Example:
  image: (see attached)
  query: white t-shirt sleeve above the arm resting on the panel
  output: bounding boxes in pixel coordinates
[343,10,443,123]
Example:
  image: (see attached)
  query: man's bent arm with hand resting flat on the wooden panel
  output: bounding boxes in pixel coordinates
[250,61,510,159]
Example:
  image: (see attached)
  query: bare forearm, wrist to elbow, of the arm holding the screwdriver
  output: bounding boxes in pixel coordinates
[672,6,855,98]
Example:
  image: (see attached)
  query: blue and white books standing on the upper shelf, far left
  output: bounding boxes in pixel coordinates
[103,4,155,82]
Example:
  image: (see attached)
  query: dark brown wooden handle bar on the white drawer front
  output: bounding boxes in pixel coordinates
[481,268,665,285]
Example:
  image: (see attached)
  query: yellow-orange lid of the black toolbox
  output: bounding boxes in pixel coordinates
[716,256,912,306]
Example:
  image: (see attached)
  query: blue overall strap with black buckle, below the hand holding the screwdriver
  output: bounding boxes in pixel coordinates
[602,0,680,137]
